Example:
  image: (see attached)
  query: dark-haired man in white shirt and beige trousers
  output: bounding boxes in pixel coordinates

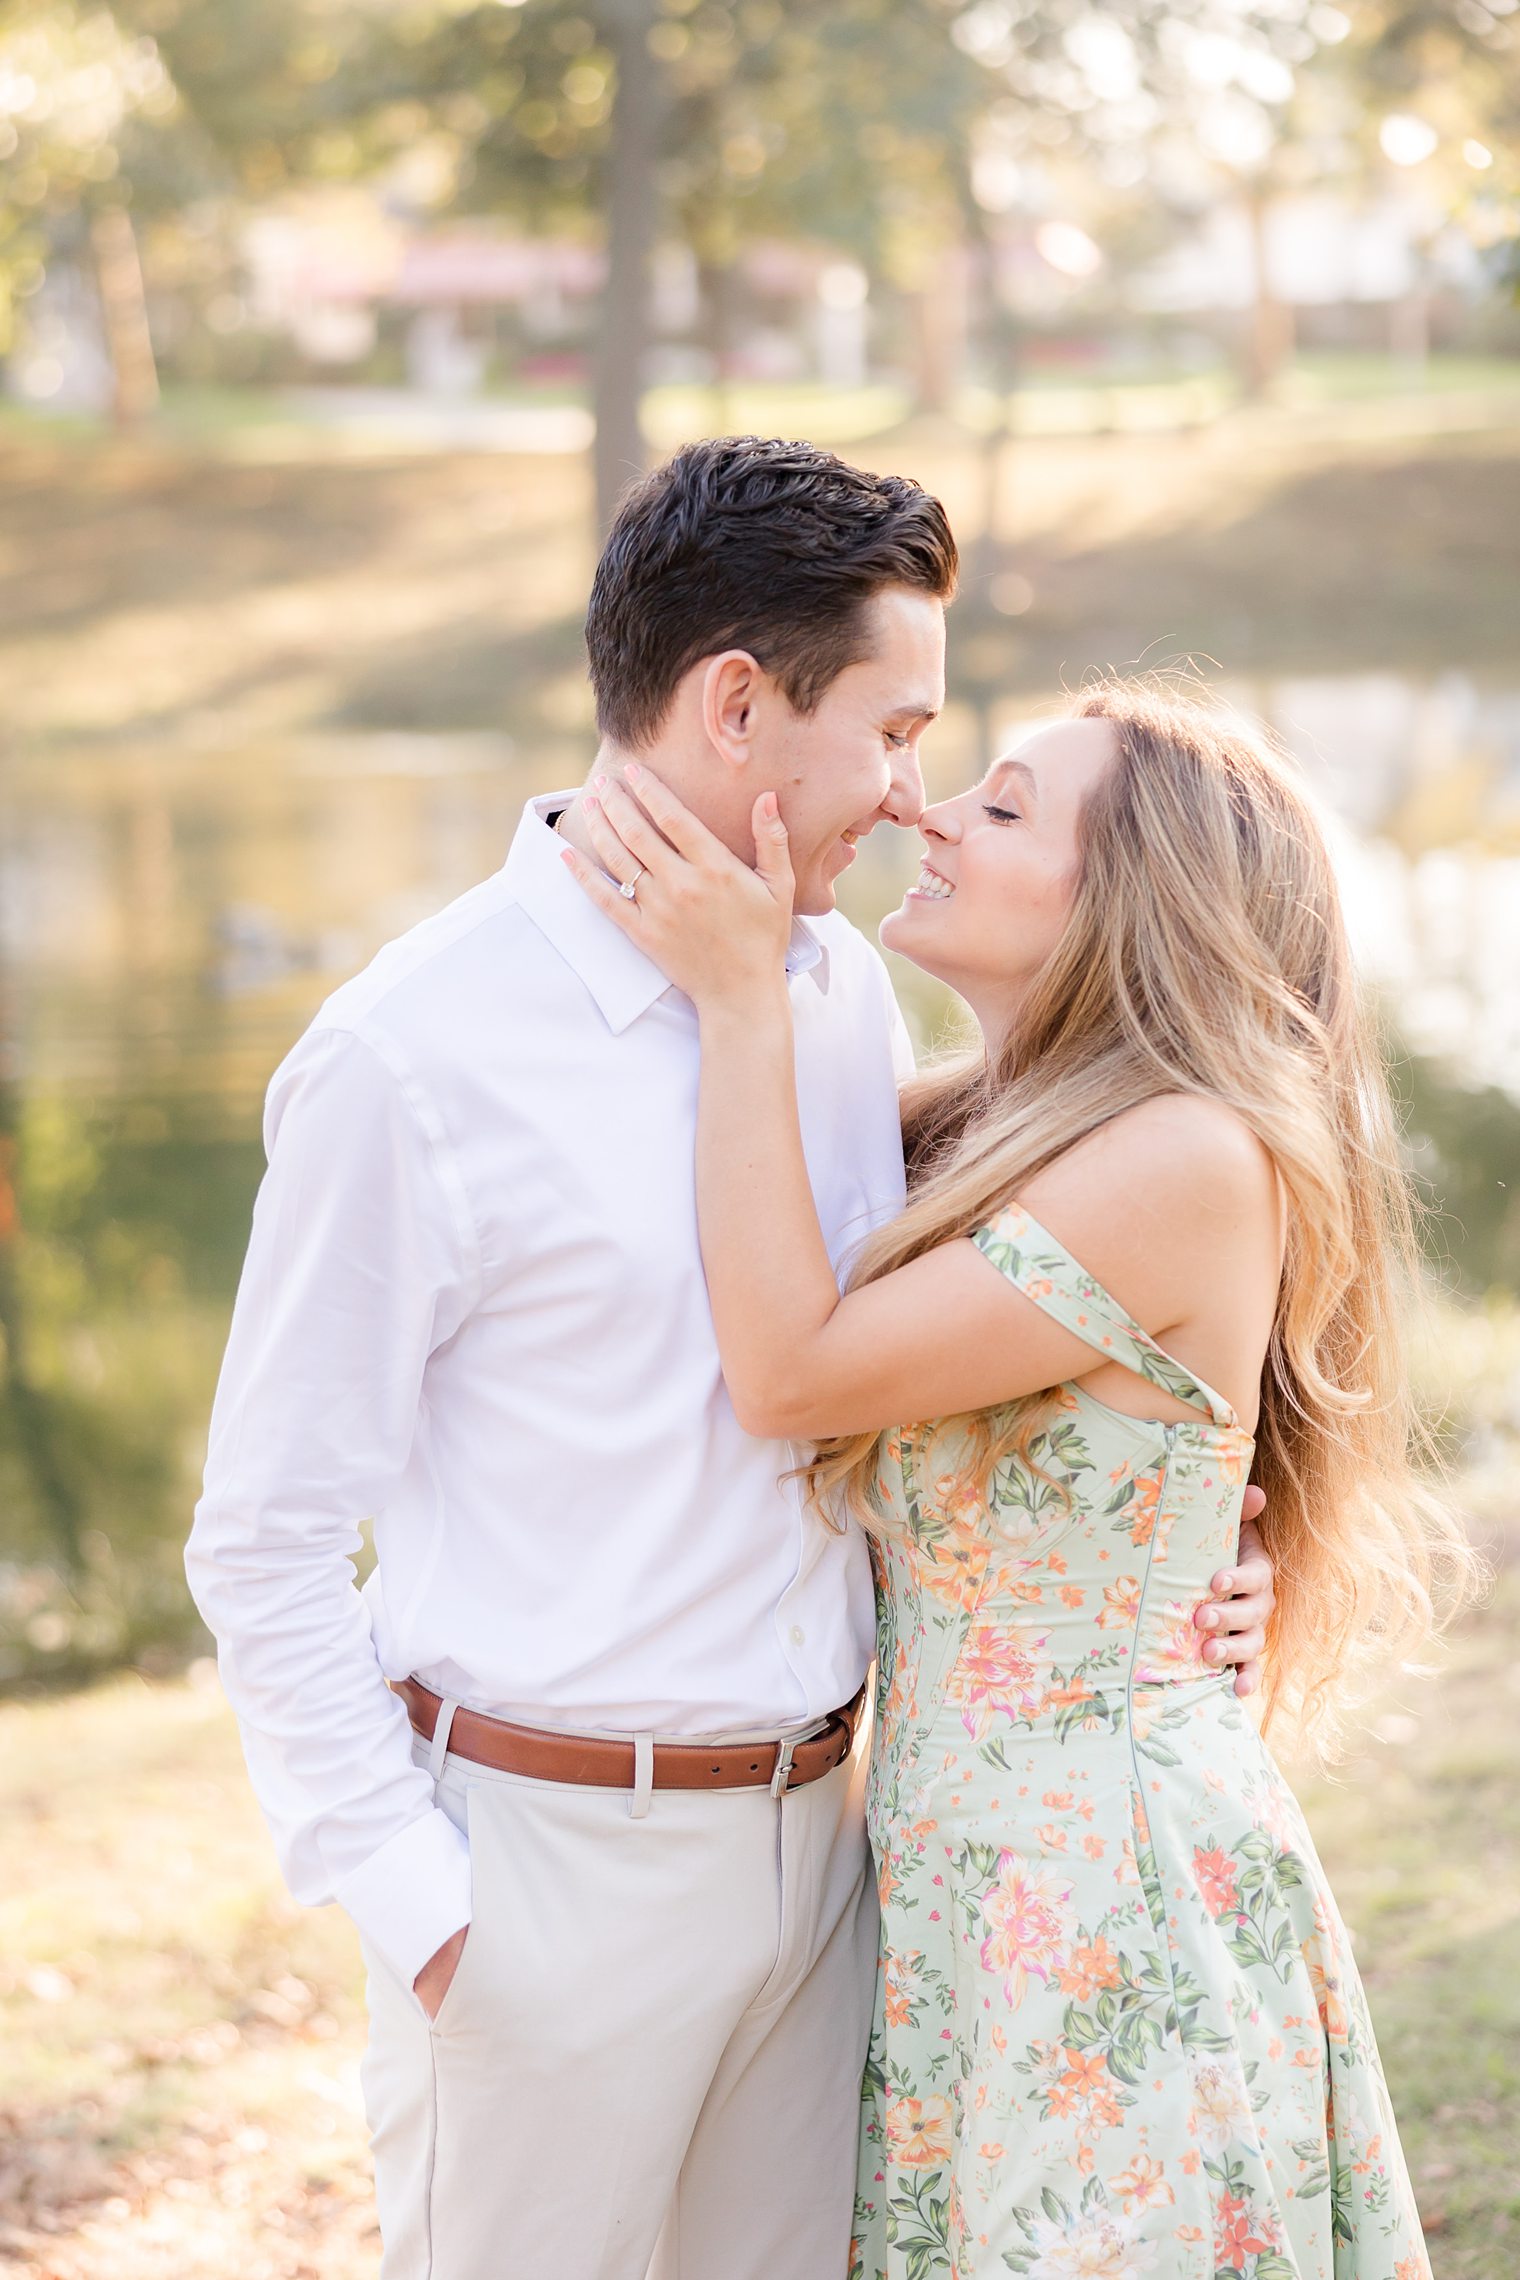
[189,438,1269,2280]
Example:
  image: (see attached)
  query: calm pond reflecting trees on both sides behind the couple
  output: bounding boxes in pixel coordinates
[0,673,1520,1678]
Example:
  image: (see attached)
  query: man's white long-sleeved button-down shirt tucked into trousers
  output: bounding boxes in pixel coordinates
[187,793,912,1981]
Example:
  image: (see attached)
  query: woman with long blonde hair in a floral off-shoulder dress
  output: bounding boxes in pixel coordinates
[574,686,1461,2280]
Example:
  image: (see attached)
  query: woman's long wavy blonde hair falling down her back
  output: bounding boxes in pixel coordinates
[809,682,1474,1749]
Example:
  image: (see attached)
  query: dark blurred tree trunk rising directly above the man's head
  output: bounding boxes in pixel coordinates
[593,0,663,531]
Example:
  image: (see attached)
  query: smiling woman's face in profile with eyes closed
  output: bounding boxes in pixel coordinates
[882,720,1119,1035]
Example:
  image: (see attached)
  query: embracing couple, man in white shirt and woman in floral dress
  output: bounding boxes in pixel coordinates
[189,438,1431,2280]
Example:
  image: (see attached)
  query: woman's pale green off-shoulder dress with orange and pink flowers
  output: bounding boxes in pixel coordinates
[850,1208,1429,2280]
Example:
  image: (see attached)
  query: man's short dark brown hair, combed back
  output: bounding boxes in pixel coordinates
[586,435,955,750]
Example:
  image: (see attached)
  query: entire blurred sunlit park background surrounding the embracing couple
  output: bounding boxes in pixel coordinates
[0,0,1520,2280]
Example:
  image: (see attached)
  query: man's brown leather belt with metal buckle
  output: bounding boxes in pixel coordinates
[392,1678,866,1797]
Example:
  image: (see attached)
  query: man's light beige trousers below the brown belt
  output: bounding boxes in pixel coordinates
[362,1714,877,2280]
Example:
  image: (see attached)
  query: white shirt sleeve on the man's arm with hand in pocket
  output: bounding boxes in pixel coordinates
[185,1026,479,1986]
